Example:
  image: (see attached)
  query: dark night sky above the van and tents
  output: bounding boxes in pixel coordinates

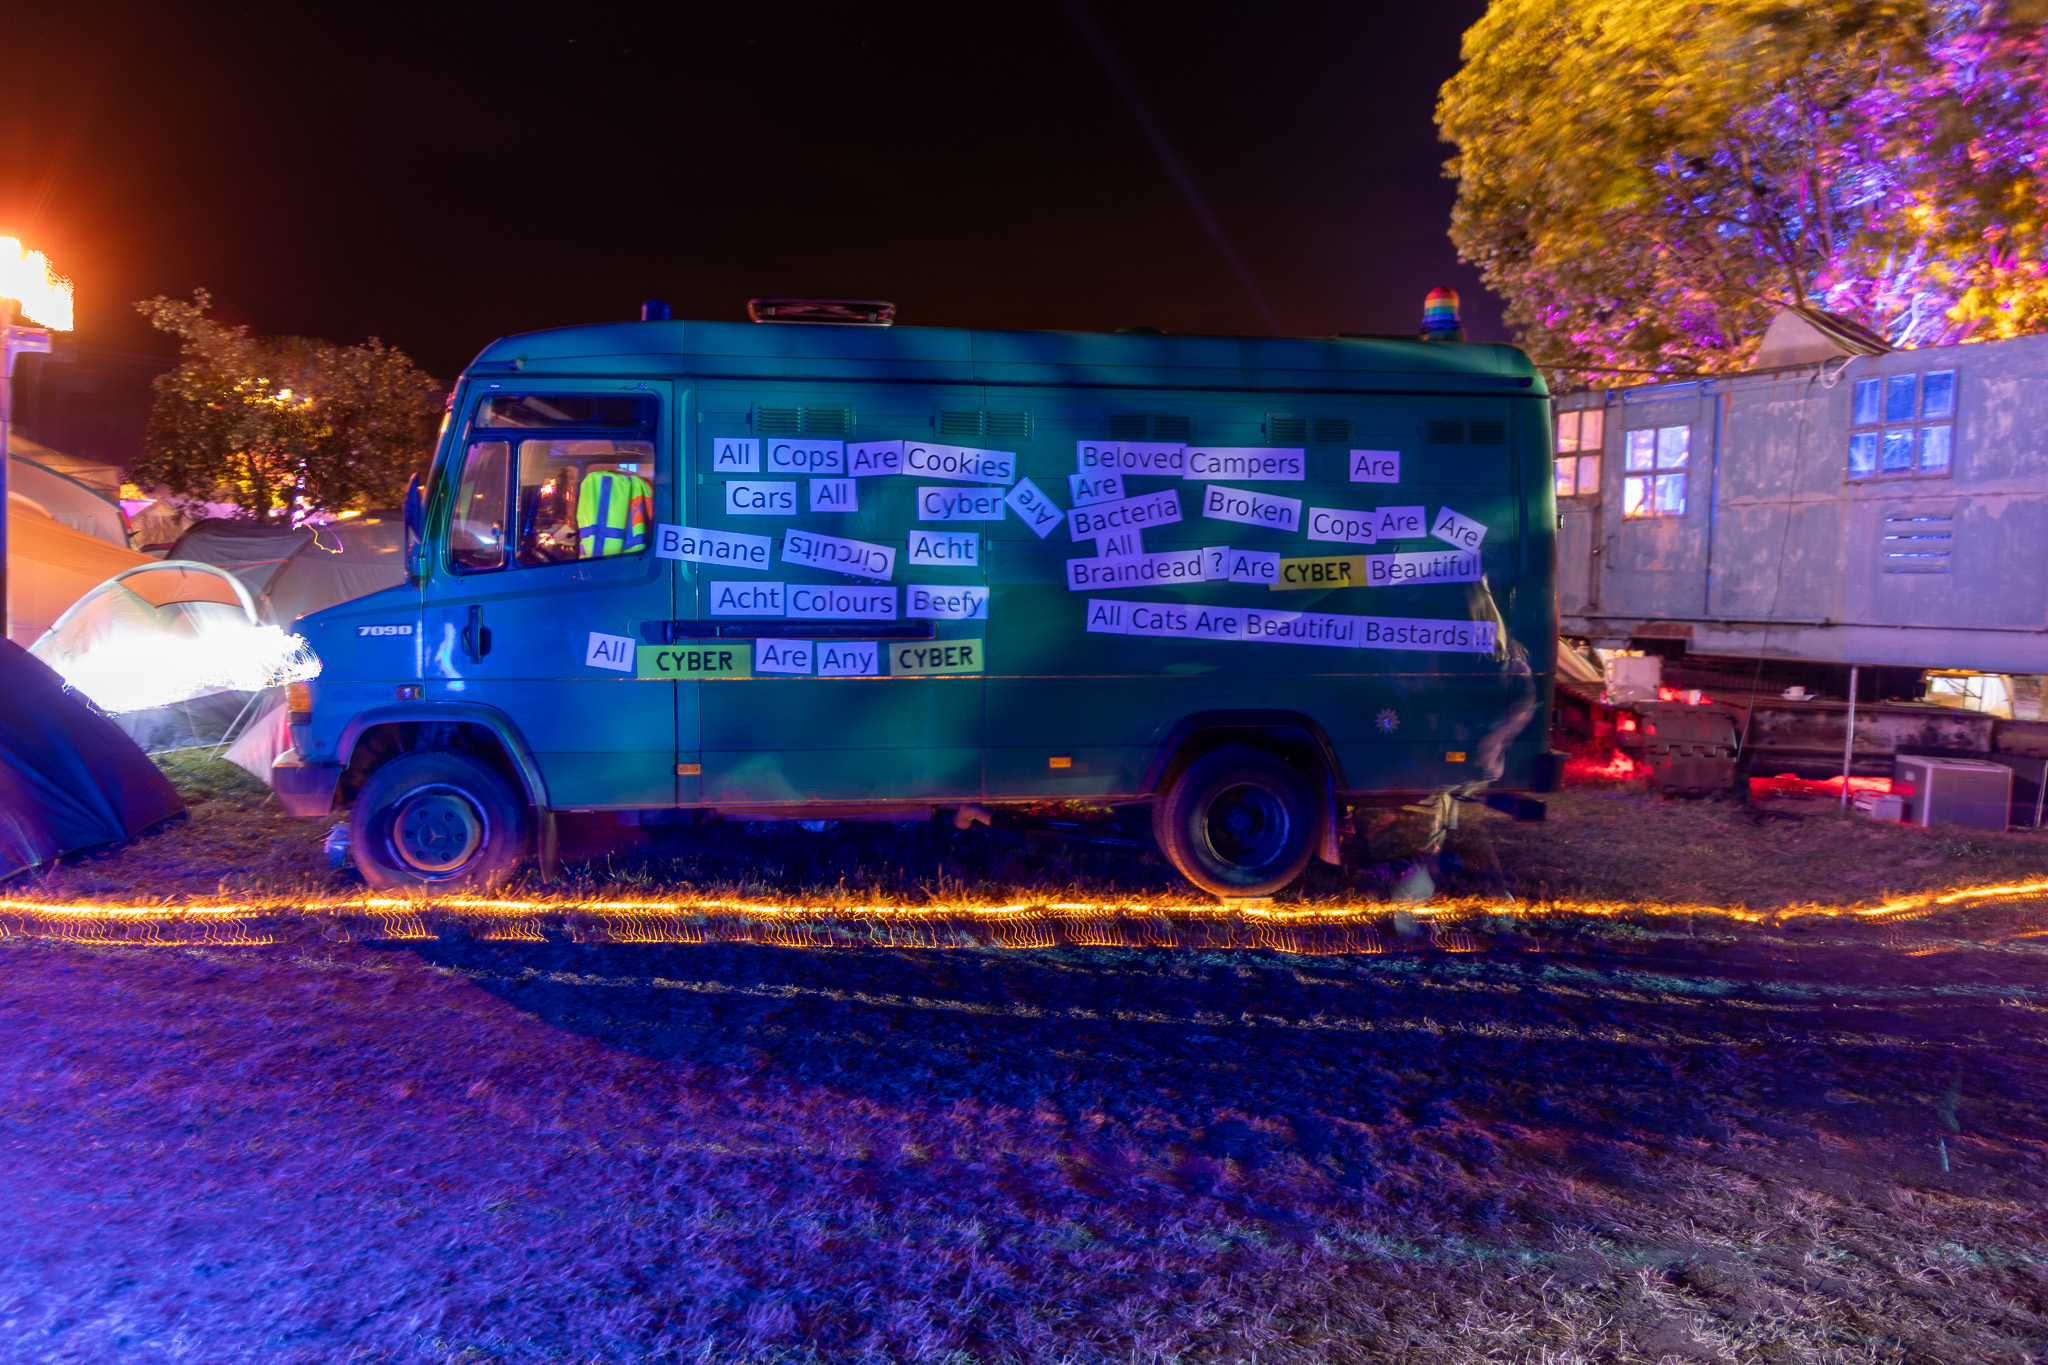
[0,0,1503,377]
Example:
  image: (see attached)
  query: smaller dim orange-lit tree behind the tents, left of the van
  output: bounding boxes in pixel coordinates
[133,289,444,518]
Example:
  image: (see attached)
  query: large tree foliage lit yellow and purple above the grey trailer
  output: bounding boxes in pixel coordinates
[1438,0,2048,383]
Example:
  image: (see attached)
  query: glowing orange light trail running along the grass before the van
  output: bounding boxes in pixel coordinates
[12,880,2048,956]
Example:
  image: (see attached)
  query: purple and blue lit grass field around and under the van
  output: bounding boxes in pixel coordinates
[0,755,2048,1365]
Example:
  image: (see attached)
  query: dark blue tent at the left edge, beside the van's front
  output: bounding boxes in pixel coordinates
[0,641,184,880]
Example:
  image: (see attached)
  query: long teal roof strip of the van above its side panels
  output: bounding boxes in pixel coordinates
[465,321,1548,395]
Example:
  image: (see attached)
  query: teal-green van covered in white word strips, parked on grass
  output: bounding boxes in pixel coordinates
[274,311,1556,896]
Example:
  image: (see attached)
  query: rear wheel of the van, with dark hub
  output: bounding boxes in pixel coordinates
[1153,745,1319,896]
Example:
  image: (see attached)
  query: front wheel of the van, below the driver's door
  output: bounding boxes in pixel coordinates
[348,749,530,890]
